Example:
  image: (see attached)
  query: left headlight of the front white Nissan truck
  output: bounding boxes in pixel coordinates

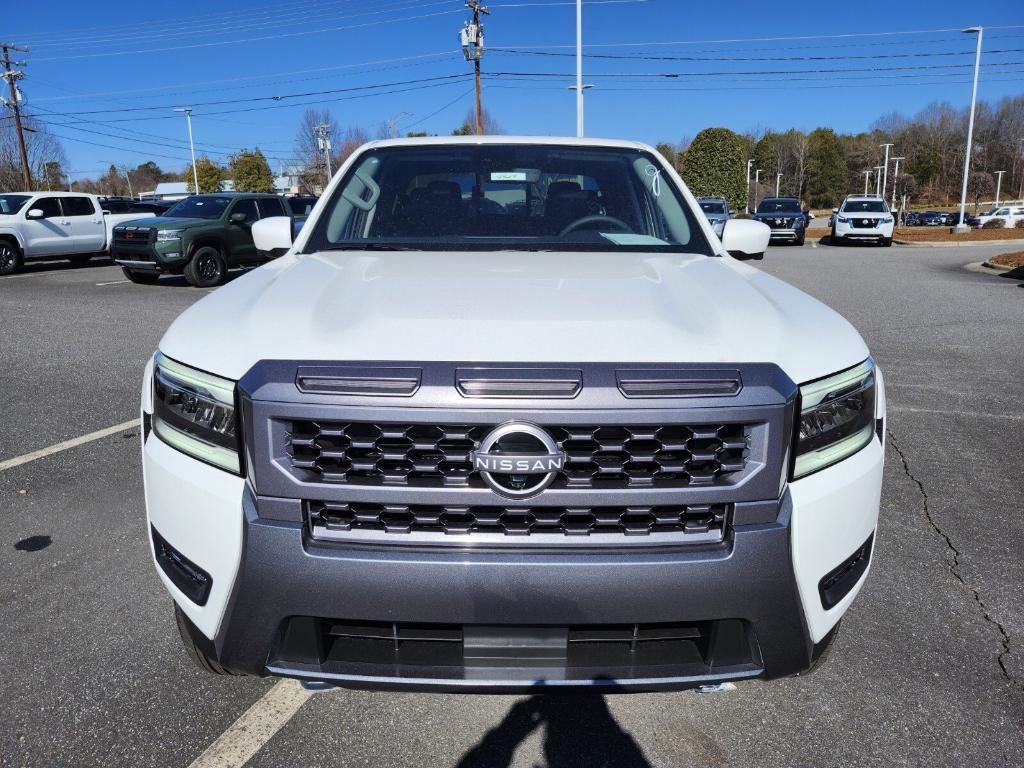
[153,352,242,474]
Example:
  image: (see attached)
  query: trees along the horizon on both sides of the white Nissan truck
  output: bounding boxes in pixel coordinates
[0,96,1024,208]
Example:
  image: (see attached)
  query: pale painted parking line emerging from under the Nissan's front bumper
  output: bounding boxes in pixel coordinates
[188,679,312,768]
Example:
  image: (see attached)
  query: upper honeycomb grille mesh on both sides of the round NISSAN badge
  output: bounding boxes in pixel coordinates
[286,420,750,488]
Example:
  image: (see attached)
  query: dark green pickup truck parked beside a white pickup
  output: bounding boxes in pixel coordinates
[111,193,296,288]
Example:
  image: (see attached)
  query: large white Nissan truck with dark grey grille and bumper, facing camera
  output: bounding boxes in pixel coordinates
[142,136,886,692]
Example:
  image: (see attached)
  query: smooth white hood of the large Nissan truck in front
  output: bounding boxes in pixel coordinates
[160,251,868,383]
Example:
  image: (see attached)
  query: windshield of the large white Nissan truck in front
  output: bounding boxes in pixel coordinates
[306,144,712,255]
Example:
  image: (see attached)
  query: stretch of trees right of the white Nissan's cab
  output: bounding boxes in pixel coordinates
[657,96,1024,208]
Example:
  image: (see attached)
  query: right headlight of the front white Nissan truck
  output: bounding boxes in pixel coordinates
[793,357,874,480]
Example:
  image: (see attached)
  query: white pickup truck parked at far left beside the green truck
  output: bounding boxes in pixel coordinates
[0,193,153,275]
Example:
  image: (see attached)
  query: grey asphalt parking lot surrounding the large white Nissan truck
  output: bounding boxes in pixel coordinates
[0,243,1024,768]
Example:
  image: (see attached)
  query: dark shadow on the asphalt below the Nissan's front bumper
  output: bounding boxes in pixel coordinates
[458,693,651,768]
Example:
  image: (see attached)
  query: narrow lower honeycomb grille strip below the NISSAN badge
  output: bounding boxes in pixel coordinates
[305,502,730,543]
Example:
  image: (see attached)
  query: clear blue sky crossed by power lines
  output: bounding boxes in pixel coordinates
[4,0,1024,177]
